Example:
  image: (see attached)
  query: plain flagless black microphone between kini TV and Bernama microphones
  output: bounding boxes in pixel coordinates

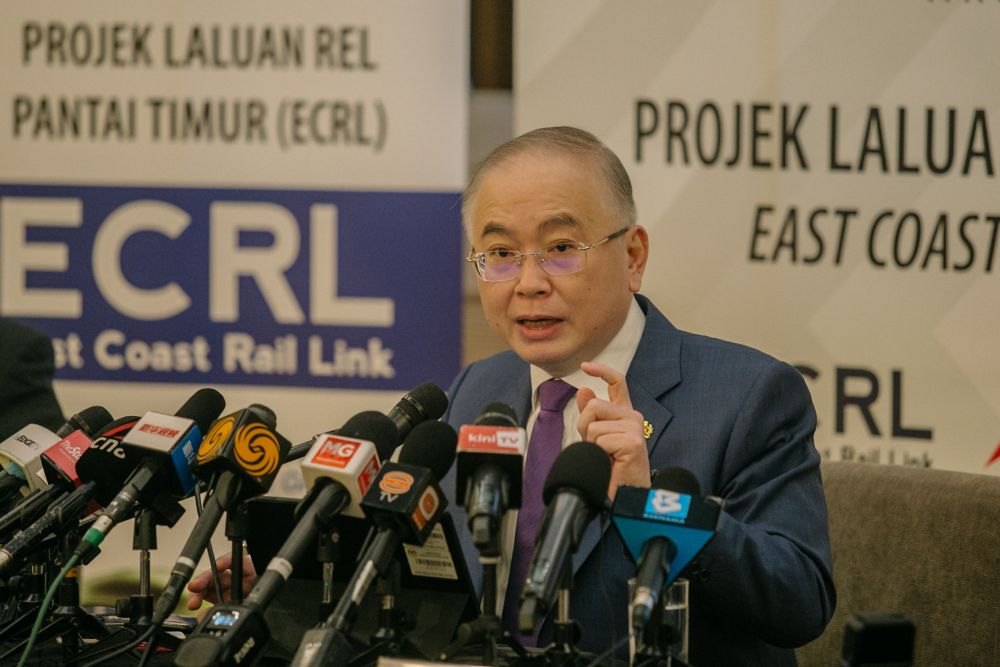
[518,442,611,634]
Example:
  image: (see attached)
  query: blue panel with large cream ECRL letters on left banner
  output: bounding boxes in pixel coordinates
[0,185,461,391]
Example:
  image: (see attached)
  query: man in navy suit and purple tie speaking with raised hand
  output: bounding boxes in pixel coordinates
[445,128,836,667]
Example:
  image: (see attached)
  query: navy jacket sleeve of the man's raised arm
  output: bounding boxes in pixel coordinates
[692,362,836,647]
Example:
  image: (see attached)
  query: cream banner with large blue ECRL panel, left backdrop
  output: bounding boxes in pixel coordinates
[0,0,468,604]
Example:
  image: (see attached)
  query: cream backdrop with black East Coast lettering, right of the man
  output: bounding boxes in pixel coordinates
[514,0,1000,480]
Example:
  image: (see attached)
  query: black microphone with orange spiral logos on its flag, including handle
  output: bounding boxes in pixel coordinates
[152,404,291,625]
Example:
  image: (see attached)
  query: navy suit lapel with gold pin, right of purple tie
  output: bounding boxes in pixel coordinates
[572,295,681,574]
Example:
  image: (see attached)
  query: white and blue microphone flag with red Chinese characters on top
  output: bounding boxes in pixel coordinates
[122,412,201,498]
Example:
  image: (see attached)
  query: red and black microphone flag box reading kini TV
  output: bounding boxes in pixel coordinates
[455,425,525,508]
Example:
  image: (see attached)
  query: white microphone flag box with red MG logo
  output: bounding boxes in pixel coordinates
[301,433,379,519]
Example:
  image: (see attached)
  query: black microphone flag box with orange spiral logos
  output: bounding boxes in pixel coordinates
[193,408,292,497]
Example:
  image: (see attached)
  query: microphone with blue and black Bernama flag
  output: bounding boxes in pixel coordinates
[612,468,722,635]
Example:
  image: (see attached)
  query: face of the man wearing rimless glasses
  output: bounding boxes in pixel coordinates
[468,153,648,377]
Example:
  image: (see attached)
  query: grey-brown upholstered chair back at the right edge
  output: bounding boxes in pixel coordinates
[797,462,1000,667]
